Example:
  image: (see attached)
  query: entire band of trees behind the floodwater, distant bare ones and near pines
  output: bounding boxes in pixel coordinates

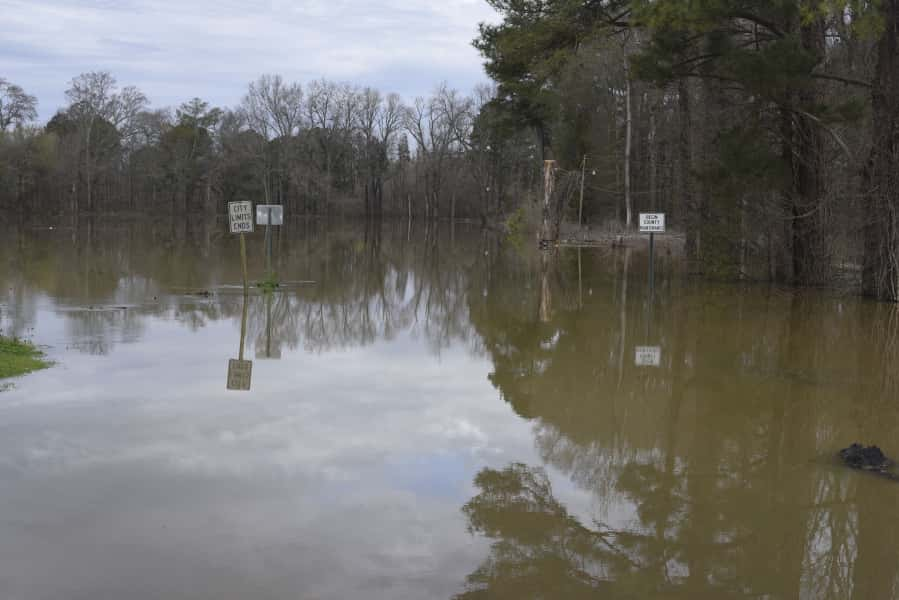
[8,0,899,301]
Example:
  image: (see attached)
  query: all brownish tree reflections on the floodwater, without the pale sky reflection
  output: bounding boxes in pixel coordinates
[0,220,899,599]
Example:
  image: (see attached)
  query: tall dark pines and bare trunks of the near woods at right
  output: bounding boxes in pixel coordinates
[475,0,899,300]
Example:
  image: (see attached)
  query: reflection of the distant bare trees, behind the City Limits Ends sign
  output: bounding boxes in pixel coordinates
[0,220,481,353]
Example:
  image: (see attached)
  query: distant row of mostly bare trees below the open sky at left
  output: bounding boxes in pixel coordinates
[0,72,536,222]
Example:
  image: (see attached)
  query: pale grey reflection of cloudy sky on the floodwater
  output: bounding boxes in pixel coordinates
[0,308,530,600]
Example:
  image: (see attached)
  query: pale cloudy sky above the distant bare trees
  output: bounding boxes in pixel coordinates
[0,0,497,120]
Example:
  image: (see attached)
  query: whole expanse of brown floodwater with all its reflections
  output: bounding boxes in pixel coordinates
[0,221,899,600]
